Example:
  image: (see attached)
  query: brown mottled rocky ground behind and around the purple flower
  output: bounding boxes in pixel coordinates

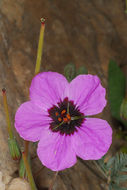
[0,0,127,190]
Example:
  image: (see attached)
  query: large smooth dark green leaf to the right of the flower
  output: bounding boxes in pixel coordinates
[108,60,127,127]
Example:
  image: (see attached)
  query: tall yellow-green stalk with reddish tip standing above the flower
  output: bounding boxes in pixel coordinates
[35,18,45,74]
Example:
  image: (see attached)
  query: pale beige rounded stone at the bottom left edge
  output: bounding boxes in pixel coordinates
[7,178,31,190]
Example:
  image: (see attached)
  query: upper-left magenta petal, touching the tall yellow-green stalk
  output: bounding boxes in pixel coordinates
[30,72,68,109]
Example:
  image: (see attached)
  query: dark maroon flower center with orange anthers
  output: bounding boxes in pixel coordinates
[48,98,84,135]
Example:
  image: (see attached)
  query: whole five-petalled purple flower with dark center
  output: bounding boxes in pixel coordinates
[15,72,112,171]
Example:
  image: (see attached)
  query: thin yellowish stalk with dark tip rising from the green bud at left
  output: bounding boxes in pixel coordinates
[2,88,14,139]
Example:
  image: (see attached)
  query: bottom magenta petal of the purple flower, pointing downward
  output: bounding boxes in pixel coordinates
[37,130,76,171]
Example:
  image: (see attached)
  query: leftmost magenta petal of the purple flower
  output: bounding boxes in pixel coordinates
[15,101,50,142]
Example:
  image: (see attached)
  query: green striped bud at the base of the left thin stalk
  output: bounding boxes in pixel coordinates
[8,138,21,160]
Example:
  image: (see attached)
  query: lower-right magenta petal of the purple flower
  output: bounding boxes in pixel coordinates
[73,118,112,160]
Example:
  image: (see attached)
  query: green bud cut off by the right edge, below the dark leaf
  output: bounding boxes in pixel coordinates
[120,98,127,120]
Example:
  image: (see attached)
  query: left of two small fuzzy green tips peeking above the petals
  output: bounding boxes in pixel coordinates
[64,63,76,82]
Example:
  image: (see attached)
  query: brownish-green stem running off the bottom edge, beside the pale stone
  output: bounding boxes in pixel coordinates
[22,152,37,190]
